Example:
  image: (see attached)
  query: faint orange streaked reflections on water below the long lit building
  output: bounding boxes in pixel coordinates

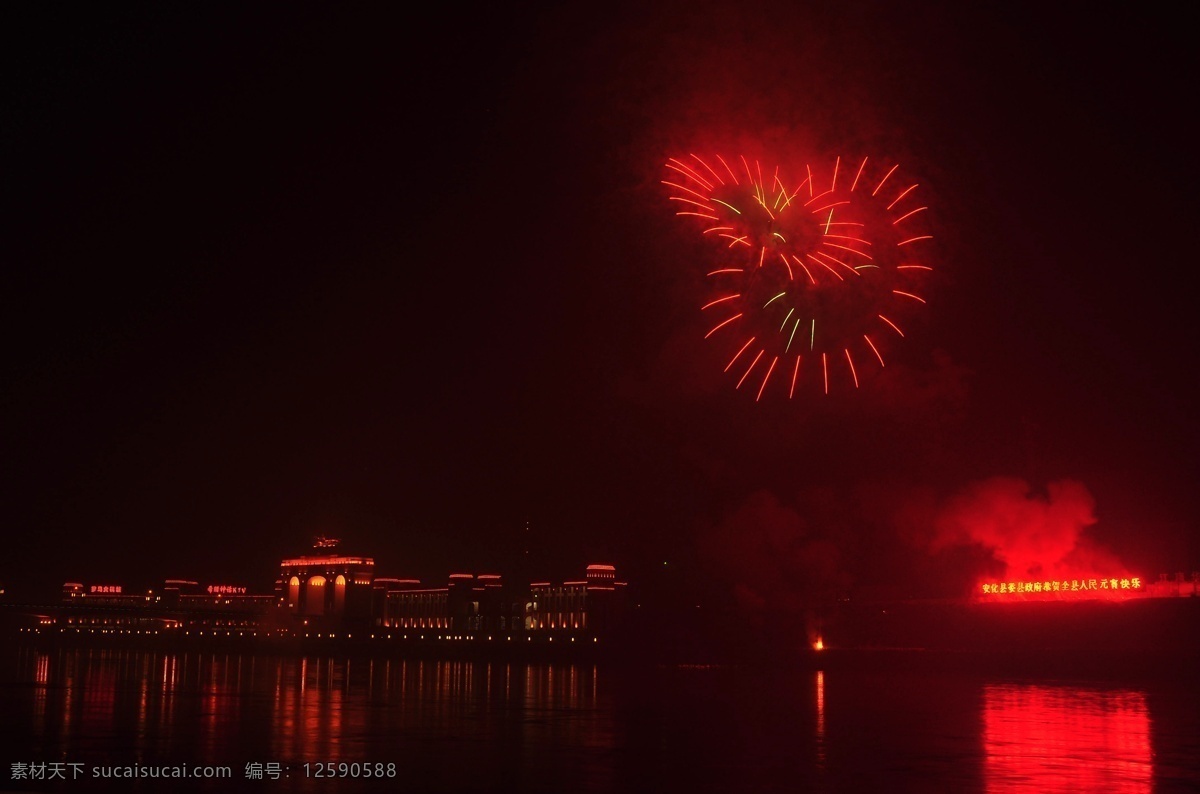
[0,649,613,789]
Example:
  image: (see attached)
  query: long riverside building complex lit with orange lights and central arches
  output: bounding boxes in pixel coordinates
[16,539,625,640]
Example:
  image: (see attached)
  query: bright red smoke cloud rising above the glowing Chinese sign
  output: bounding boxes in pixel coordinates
[929,477,1124,578]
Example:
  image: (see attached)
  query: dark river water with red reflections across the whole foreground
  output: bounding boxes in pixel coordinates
[0,645,1200,794]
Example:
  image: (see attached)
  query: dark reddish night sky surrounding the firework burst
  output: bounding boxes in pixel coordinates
[0,1,1200,604]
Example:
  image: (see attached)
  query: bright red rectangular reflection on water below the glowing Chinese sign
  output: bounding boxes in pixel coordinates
[984,685,1153,794]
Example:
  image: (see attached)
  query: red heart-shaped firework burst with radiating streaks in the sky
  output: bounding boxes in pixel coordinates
[664,155,931,401]
